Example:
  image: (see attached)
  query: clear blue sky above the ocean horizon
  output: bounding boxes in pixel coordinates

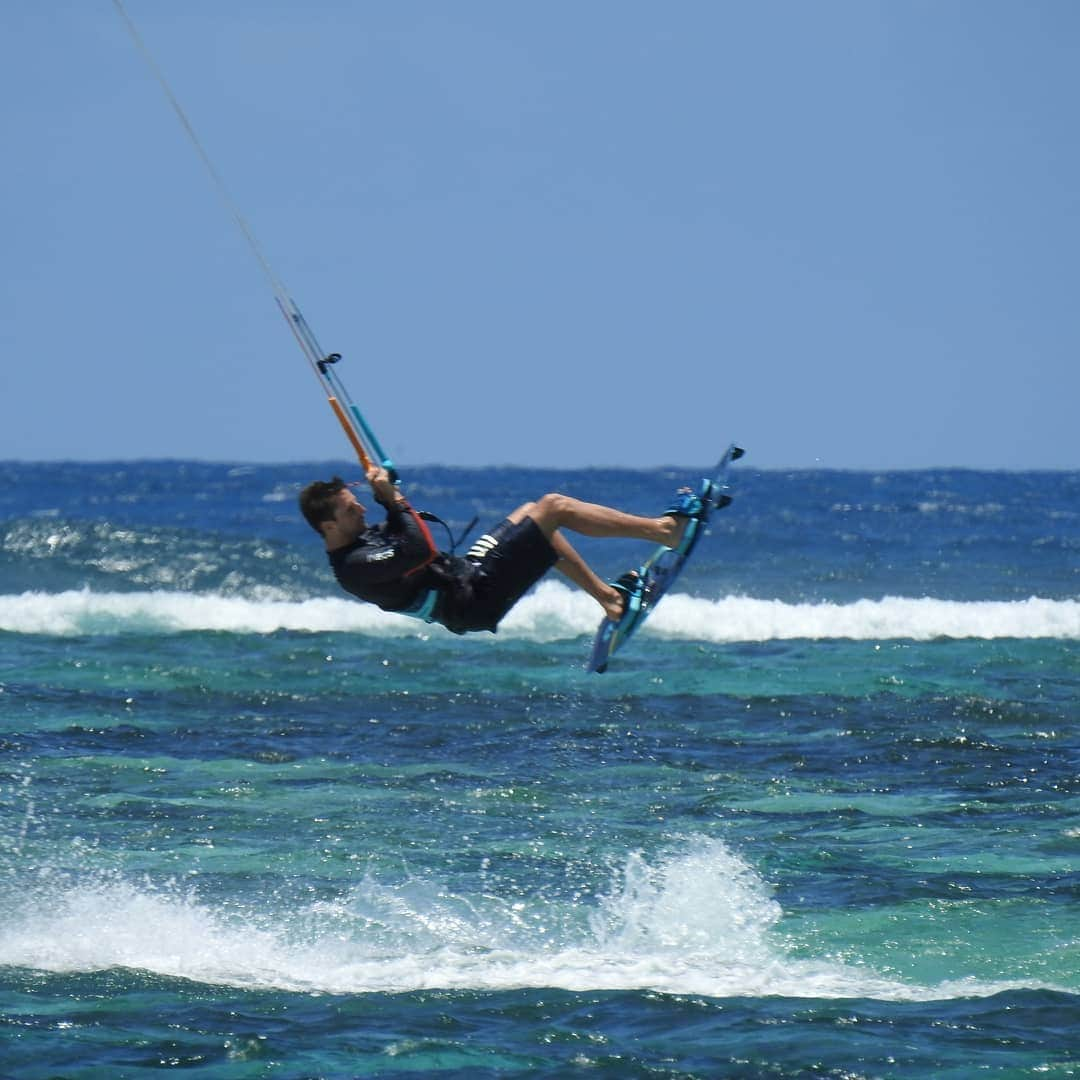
[0,0,1080,469]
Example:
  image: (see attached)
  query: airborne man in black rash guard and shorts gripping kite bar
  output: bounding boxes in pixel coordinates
[300,465,702,634]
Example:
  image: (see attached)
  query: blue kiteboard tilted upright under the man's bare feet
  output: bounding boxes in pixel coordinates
[585,443,745,674]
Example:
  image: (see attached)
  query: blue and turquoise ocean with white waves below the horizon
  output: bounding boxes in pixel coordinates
[0,455,1080,1080]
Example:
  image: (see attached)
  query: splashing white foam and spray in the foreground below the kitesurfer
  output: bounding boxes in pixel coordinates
[0,837,1054,1000]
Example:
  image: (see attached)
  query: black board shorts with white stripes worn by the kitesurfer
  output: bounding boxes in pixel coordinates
[440,517,558,634]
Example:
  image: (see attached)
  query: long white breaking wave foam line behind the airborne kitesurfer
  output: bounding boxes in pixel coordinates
[0,581,1080,644]
